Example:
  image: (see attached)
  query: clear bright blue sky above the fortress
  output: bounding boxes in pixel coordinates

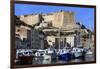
[14,4,94,31]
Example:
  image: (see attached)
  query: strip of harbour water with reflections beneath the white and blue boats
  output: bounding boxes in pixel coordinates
[33,55,94,64]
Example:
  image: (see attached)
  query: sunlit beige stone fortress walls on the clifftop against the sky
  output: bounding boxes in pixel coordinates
[19,11,76,28]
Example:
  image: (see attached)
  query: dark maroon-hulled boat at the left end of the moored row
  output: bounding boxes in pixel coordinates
[15,49,34,64]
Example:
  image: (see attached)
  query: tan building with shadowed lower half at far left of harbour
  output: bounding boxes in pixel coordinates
[15,26,31,49]
